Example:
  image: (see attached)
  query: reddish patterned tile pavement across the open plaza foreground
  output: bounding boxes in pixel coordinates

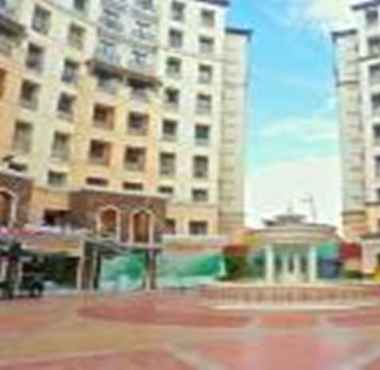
[0,293,380,370]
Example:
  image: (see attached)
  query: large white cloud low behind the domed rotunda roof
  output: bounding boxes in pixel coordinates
[246,156,341,230]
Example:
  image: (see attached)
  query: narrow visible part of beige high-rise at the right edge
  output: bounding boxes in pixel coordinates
[333,1,380,238]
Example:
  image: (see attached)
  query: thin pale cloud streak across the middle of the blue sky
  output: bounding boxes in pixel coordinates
[259,118,338,144]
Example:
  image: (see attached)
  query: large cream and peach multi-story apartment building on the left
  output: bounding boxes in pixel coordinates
[0,0,250,244]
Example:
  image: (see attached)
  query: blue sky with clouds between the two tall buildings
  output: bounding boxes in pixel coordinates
[229,0,346,225]
